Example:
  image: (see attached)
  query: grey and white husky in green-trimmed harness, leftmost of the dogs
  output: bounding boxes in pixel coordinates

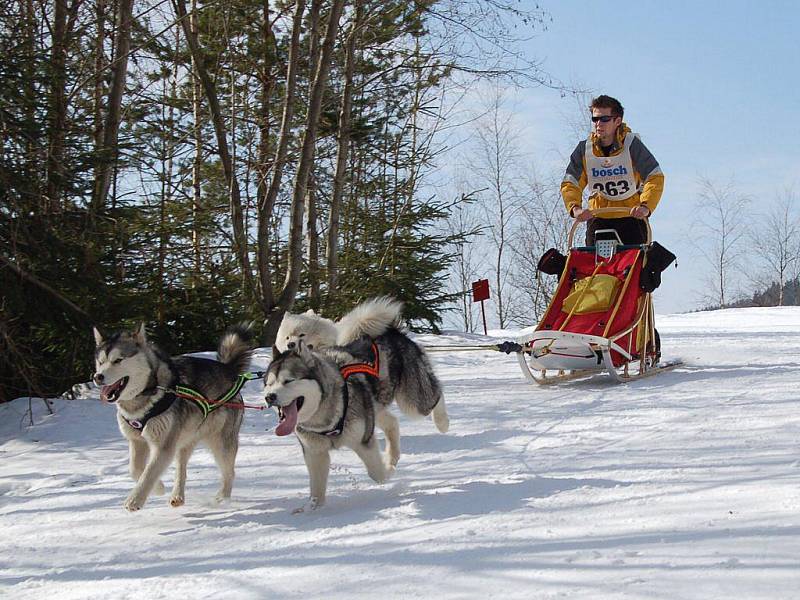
[94,324,252,511]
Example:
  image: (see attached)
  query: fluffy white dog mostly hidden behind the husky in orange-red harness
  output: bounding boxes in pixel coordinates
[275,296,403,352]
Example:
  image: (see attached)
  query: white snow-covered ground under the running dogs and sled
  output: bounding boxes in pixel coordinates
[0,308,800,600]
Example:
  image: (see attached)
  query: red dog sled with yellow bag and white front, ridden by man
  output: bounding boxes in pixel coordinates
[517,208,682,385]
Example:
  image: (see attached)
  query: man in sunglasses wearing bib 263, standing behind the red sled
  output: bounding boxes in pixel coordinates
[561,96,664,246]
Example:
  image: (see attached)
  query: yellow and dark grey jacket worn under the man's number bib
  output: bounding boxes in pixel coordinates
[561,123,664,214]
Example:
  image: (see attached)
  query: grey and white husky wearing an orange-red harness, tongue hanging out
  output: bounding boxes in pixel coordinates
[264,327,449,512]
